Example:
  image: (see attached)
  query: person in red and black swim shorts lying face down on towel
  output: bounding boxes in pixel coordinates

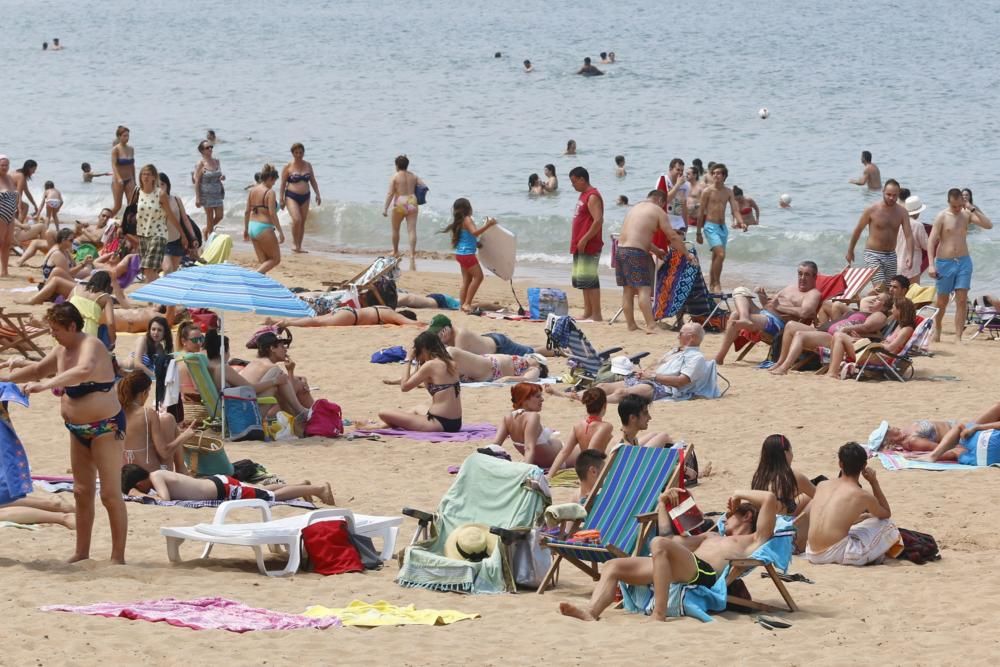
[122,463,336,505]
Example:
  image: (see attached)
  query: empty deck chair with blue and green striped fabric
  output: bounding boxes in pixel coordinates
[538,445,689,594]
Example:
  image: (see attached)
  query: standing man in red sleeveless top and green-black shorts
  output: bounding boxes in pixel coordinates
[569,167,604,322]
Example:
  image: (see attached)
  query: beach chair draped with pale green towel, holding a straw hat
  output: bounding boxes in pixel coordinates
[396,453,551,593]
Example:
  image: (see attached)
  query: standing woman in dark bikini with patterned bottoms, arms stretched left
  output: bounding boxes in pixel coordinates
[0,303,128,564]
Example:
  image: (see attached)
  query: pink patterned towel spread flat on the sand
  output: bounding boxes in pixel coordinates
[41,598,340,632]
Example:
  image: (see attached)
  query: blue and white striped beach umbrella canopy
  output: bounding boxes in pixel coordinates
[128,264,316,317]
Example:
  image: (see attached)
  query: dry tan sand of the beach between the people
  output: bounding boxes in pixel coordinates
[0,249,1000,665]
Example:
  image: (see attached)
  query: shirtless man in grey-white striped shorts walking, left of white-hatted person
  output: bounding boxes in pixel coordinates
[846,178,913,291]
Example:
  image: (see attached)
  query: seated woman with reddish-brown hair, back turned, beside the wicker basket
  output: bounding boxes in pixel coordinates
[118,371,194,475]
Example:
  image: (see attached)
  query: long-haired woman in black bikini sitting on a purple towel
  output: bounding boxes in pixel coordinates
[378,331,462,433]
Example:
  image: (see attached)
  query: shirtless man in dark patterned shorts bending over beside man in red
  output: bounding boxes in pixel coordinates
[615,190,693,334]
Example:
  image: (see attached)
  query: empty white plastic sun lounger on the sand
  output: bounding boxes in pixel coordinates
[160,498,403,577]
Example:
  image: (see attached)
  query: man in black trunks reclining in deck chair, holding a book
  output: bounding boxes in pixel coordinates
[559,488,778,621]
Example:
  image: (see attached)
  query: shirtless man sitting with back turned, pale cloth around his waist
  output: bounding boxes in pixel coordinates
[804,442,899,566]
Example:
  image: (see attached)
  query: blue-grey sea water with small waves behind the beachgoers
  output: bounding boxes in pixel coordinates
[7,0,1000,293]
